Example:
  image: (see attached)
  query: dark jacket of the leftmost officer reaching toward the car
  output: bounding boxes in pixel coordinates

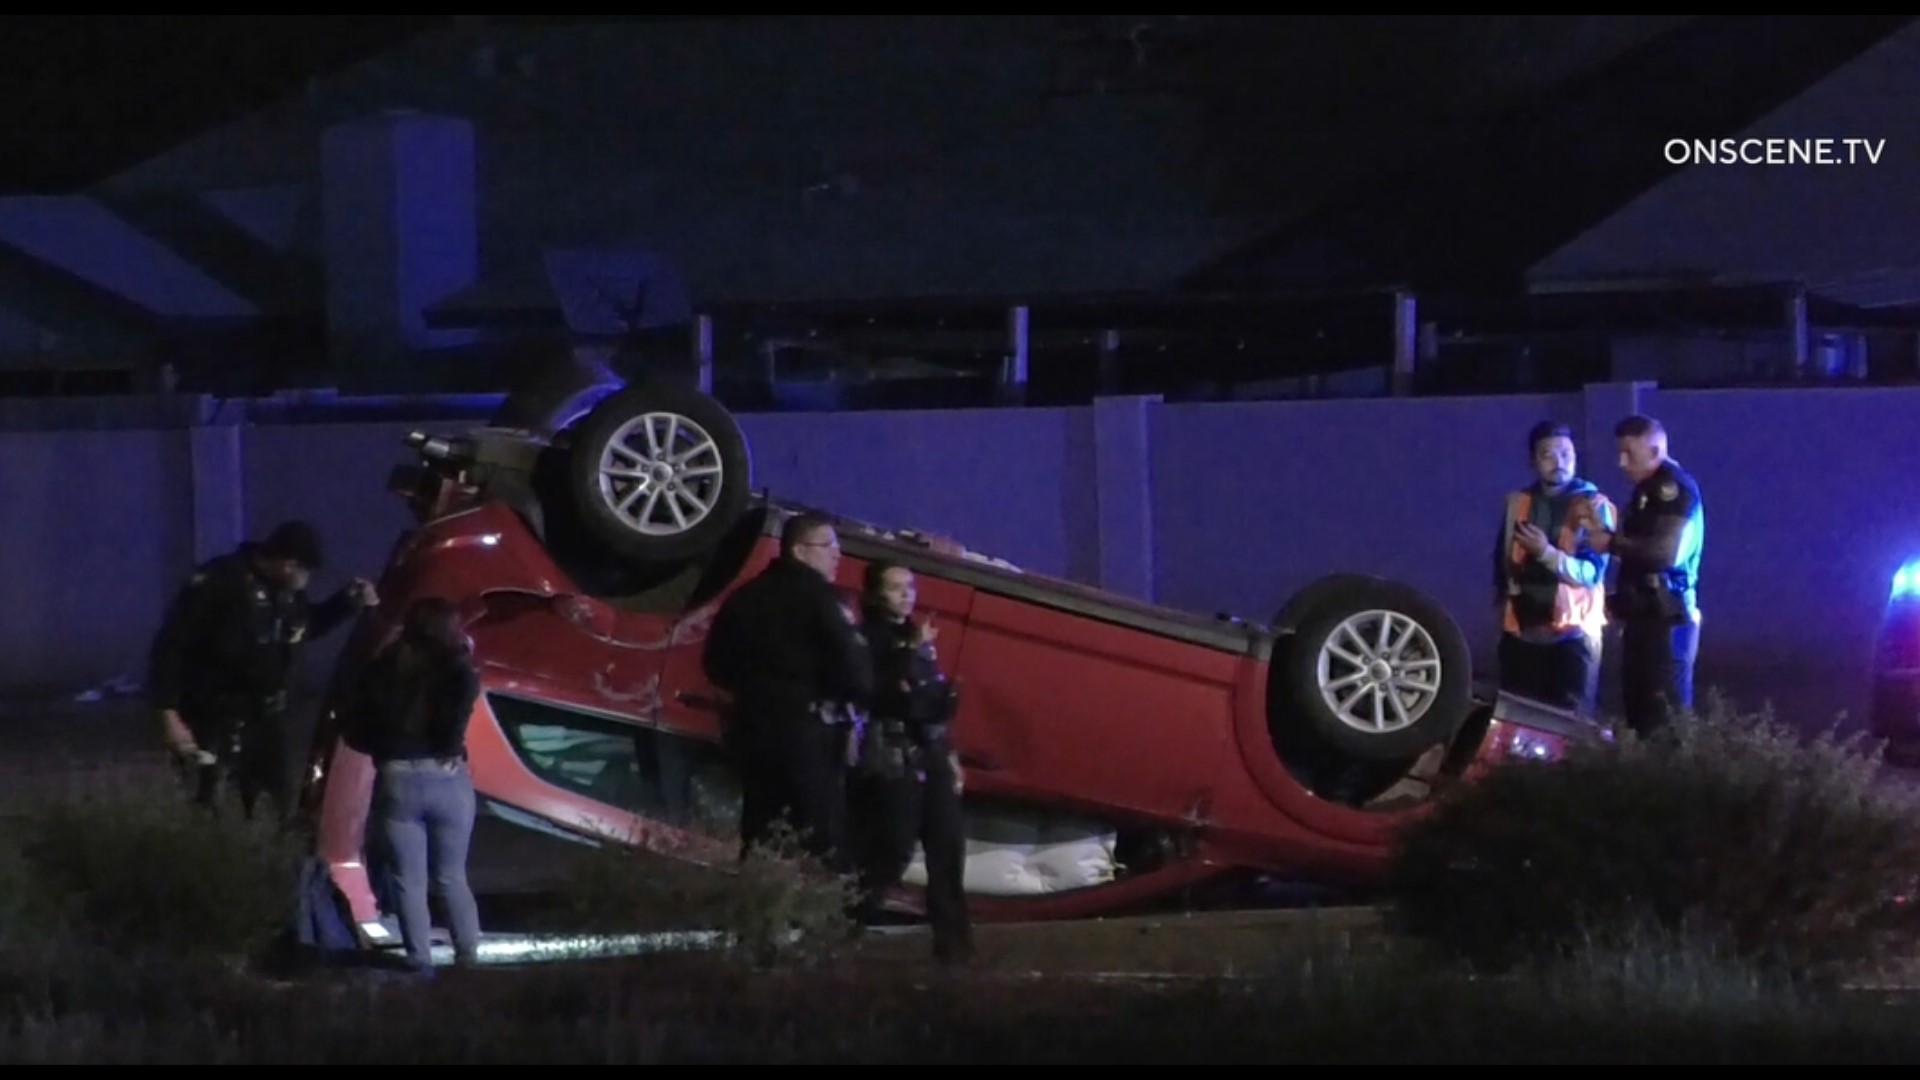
[148,544,353,713]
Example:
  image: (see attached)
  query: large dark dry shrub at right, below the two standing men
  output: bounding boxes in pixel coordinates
[1394,687,1920,978]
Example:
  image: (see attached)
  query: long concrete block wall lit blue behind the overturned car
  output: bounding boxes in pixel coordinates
[0,384,1920,721]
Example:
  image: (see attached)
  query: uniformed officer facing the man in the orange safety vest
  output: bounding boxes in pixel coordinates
[1592,415,1707,736]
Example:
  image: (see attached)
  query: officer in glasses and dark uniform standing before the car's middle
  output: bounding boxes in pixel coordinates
[701,513,874,871]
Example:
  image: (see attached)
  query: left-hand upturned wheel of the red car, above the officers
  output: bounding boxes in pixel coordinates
[566,380,753,561]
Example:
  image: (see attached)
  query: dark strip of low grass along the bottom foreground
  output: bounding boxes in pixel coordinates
[18,914,1920,1065]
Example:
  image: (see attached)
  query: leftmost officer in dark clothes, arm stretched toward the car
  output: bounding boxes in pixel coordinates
[148,521,378,819]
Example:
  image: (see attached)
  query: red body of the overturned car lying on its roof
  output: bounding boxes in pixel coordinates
[307,438,1592,944]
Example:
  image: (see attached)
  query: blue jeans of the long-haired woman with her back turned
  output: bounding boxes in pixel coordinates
[372,761,480,970]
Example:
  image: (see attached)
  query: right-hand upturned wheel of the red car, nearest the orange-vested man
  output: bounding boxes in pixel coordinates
[1273,575,1473,761]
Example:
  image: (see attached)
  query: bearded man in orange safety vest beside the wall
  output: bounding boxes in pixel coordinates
[1494,421,1615,715]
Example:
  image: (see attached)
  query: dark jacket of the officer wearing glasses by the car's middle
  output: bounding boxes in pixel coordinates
[701,557,874,713]
